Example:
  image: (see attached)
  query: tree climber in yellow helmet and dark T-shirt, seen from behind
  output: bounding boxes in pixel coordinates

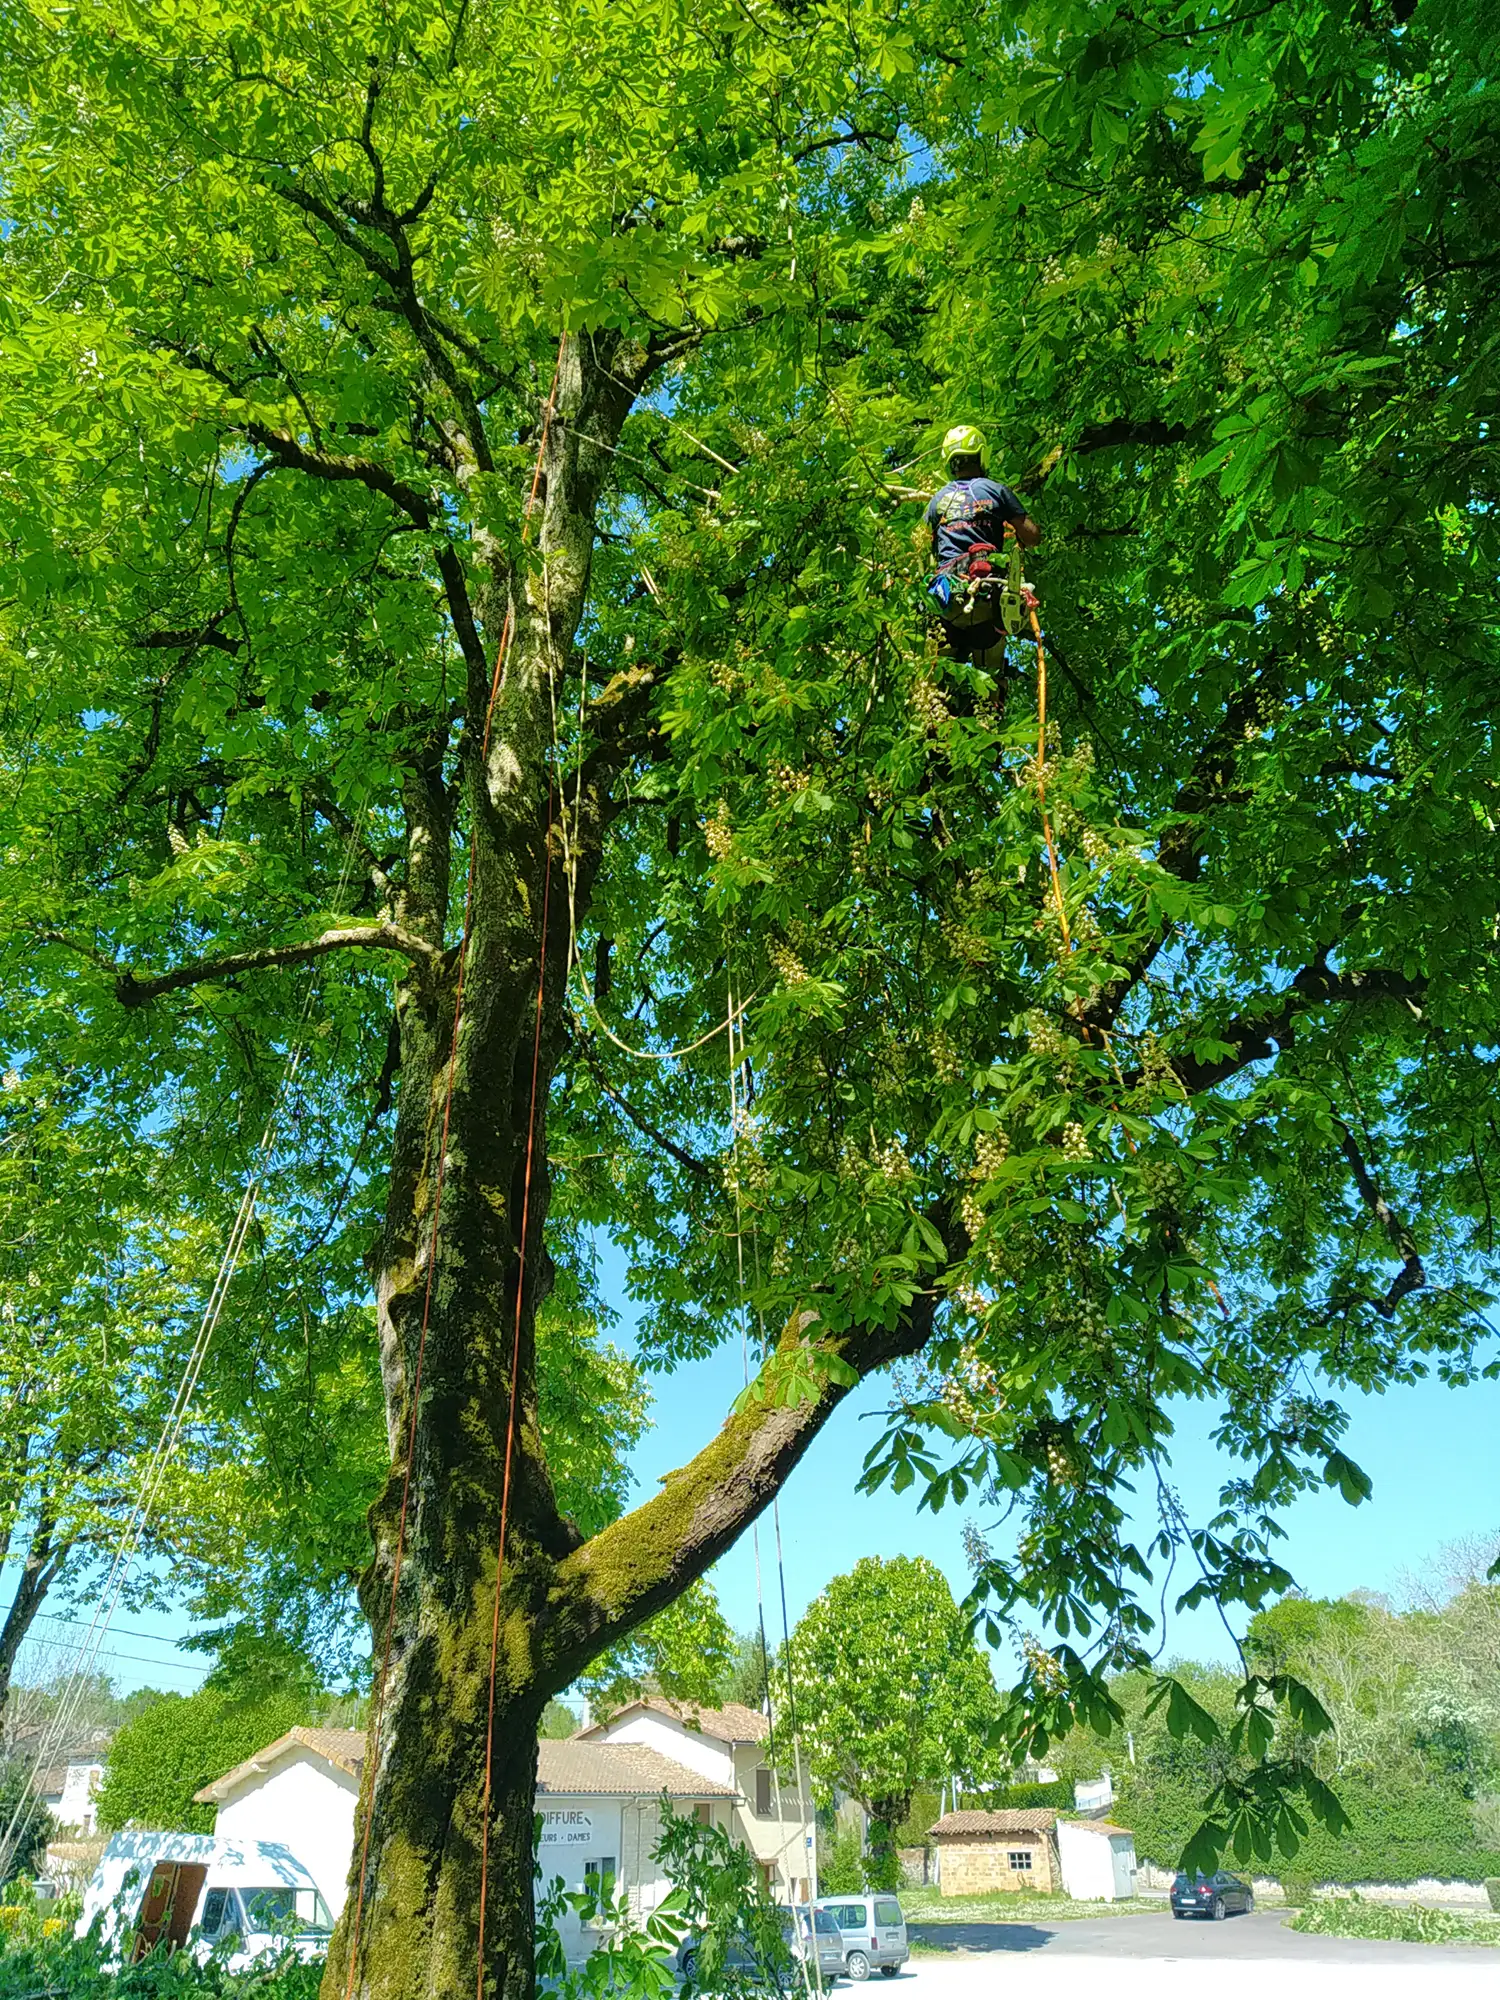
[926,424,1042,670]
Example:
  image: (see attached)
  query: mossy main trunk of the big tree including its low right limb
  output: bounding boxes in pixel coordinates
[278,338,944,2000]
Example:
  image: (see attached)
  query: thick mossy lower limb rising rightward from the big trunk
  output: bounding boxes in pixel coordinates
[542,1292,938,1688]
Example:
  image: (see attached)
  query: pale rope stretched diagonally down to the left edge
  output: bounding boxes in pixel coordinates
[0,806,368,1880]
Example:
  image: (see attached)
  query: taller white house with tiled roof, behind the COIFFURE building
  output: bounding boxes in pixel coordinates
[574,1694,812,1902]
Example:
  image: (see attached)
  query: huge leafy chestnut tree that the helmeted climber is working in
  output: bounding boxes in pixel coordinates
[0,0,1500,2000]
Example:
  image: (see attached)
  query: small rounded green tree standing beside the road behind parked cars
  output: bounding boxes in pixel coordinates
[790,1556,1000,1888]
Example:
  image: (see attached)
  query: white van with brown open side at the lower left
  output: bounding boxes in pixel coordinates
[76,1832,334,1972]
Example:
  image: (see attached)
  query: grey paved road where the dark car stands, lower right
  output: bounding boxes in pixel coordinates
[904,1910,1500,1968]
